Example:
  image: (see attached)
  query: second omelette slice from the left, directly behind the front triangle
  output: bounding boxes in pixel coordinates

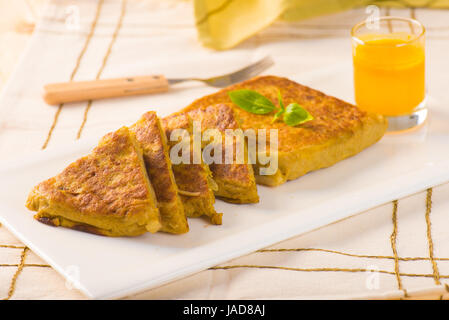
[131,111,189,233]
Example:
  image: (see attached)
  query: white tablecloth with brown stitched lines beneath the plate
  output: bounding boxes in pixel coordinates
[0,0,449,299]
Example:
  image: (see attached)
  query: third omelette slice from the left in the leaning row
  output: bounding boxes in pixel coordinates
[161,114,222,224]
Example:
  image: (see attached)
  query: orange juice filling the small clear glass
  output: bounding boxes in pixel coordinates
[353,33,426,116]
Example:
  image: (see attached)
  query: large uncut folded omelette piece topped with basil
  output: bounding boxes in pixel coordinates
[183,76,388,186]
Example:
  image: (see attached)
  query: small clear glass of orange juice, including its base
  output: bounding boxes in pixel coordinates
[351,17,427,131]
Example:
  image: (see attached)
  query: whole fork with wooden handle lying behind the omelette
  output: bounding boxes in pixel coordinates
[43,56,274,105]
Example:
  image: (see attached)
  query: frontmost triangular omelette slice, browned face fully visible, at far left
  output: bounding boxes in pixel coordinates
[26,127,161,236]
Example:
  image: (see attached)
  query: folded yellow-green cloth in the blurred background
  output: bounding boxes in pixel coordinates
[195,0,449,50]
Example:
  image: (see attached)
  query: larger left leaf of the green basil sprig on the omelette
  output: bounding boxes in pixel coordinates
[228,89,276,114]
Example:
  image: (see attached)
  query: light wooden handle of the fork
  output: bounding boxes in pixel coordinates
[44,75,168,104]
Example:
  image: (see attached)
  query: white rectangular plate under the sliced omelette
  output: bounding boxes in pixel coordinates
[0,94,449,298]
